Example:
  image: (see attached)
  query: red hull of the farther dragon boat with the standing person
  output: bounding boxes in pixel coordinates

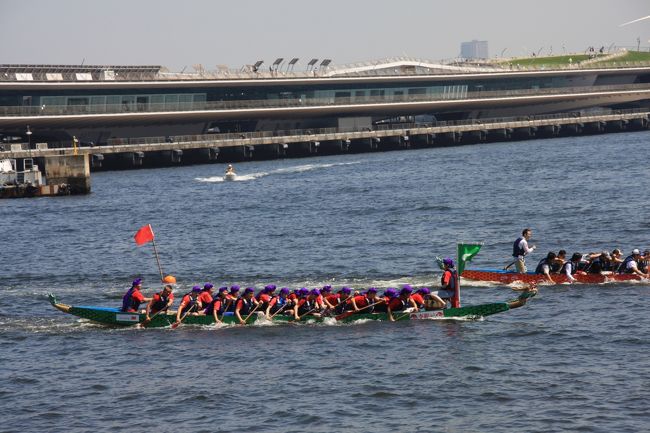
[461,269,644,284]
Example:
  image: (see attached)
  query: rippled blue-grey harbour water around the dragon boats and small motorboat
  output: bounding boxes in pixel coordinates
[0,132,650,432]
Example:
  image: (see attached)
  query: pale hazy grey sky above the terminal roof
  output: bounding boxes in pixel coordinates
[0,0,650,71]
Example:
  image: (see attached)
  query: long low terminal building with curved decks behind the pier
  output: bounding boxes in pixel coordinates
[0,57,650,145]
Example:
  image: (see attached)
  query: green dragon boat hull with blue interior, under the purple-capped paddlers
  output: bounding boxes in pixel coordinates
[48,290,537,328]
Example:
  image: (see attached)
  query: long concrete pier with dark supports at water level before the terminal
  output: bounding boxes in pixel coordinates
[0,106,650,164]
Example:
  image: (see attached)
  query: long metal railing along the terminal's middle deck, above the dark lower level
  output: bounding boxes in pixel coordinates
[0,83,650,117]
